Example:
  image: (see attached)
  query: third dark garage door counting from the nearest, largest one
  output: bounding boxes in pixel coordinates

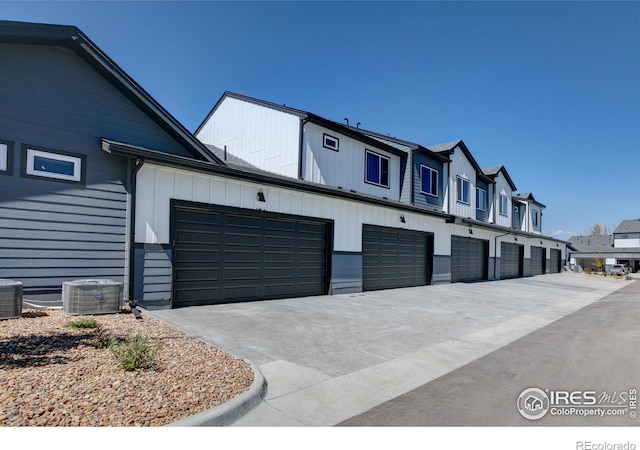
[451,236,489,283]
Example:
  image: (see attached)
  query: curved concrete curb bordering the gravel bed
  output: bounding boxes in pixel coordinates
[165,359,267,427]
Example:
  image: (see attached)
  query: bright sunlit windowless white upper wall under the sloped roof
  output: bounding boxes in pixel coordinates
[196,97,300,178]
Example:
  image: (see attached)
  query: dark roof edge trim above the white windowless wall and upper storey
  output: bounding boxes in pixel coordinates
[194,91,407,156]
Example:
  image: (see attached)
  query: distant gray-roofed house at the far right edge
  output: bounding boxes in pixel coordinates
[569,219,640,272]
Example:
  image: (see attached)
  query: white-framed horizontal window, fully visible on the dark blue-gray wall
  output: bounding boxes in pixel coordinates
[24,147,83,182]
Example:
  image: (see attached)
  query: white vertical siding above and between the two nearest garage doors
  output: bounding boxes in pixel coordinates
[135,163,451,255]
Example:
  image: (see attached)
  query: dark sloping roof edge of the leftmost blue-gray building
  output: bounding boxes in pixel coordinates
[0,20,223,164]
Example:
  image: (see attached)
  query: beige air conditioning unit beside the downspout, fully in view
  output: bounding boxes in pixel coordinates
[62,279,123,315]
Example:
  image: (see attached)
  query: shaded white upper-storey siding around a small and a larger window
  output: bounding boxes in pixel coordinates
[302,123,401,201]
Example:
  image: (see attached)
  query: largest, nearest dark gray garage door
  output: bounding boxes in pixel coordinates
[172,202,330,308]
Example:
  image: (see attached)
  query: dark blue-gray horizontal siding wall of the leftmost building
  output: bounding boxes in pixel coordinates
[0,44,200,298]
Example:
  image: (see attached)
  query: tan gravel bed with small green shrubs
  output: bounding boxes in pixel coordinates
[0,309,253,427]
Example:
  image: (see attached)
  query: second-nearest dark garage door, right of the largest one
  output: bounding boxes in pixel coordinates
[362,225,433,291]
